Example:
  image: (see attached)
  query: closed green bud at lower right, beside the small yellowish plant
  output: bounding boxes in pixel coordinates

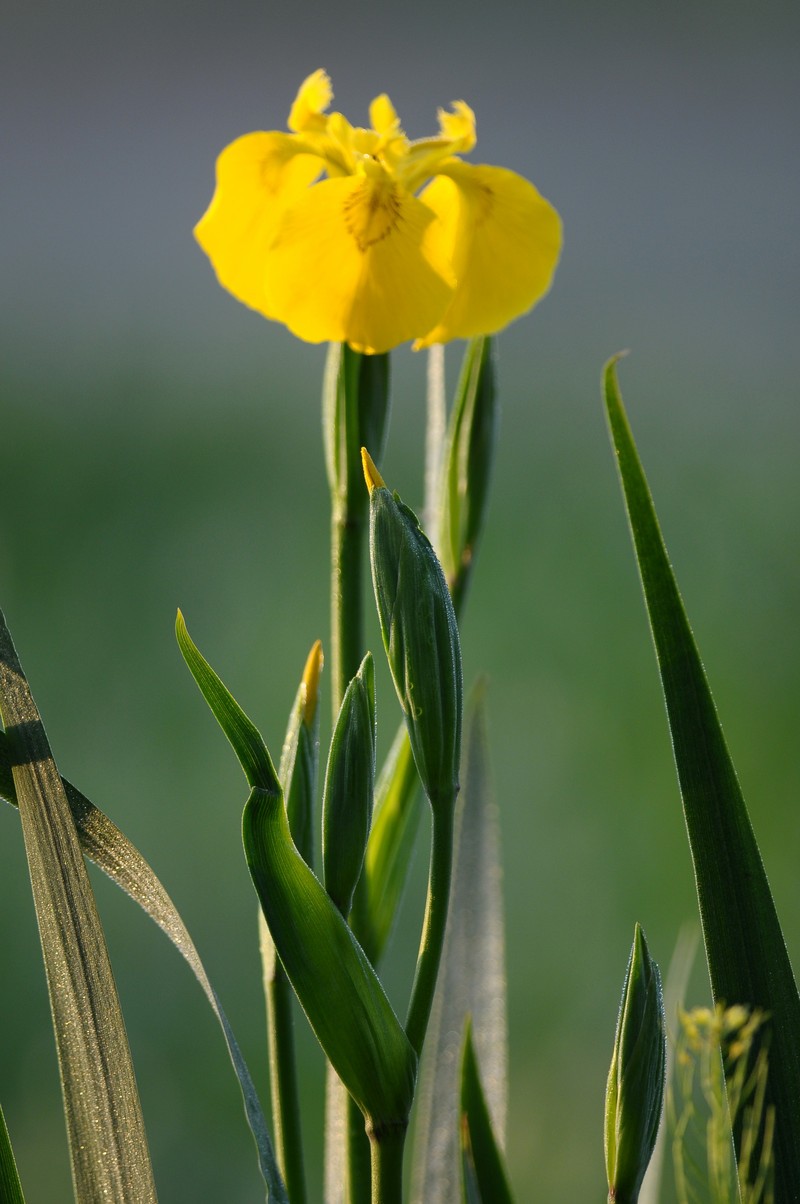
[605,925,666,1204]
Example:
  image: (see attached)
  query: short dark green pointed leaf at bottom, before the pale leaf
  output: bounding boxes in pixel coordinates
[460,1020,512,1204]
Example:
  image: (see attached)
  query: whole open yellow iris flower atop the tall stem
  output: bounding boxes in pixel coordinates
[194,71,561,352]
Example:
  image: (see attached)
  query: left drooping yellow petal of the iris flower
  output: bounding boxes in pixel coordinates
[194,132,323,318]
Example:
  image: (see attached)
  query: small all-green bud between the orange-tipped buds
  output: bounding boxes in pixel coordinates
[322,653,376,916]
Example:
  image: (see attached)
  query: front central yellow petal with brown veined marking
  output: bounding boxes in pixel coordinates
[266,174,453,352]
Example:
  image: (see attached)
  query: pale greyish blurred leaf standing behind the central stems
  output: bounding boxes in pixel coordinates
[412,689,507,1204]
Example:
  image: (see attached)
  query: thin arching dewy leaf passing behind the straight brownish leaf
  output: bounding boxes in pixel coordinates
[0,732,287,1204]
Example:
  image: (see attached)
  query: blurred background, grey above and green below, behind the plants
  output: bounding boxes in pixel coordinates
[0,0,800,1204]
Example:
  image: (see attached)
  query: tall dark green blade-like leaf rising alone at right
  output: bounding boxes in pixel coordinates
[605,360,800,1204]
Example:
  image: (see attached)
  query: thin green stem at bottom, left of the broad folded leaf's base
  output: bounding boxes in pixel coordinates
[264,956,306,1204]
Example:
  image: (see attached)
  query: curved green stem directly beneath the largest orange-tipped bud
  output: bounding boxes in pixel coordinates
[406,795,455,1057]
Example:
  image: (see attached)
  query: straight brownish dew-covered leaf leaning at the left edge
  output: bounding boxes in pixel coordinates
[0,614,155,1204]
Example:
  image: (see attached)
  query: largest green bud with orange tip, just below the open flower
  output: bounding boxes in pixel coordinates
[361,449,461,808]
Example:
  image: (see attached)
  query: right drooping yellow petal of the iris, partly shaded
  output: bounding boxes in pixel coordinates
[417,159,561,347]
